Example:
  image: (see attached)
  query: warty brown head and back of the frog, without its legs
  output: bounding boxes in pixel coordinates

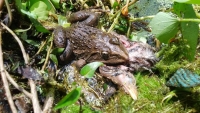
[66,24,128,64]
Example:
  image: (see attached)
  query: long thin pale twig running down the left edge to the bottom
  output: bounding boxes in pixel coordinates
[0,29,17,113]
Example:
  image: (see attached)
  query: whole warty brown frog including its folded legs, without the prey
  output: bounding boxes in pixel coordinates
[54,11,129,64]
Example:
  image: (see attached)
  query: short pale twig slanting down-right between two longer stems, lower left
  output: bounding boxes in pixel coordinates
[5,71,32,99]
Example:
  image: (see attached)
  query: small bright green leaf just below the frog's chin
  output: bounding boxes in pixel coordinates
[80,62,103,78]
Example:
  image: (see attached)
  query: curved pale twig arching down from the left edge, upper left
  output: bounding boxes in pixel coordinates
[1,22,28,65]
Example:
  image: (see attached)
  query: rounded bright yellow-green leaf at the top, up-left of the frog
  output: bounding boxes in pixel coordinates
[29,1,49,20]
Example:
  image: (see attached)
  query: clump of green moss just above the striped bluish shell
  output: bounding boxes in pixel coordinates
[155,40,189,77]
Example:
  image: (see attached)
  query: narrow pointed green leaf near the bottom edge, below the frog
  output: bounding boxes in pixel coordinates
[54,87,81,110]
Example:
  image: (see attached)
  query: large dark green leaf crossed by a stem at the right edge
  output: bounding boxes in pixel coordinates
[174,3,199,60]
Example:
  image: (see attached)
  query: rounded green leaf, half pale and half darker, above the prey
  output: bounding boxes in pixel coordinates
[149,12,180,43]
